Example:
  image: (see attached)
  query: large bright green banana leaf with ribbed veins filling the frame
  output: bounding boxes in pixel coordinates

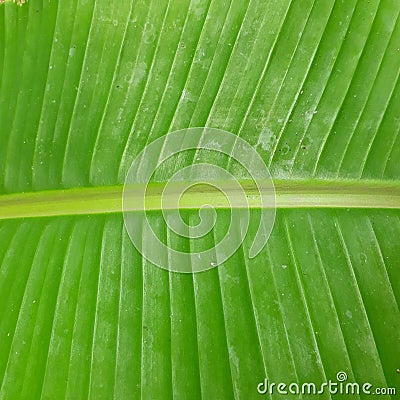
[0,0,400,399]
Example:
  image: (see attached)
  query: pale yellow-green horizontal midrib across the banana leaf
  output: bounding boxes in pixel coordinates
[0,180,400,219]
